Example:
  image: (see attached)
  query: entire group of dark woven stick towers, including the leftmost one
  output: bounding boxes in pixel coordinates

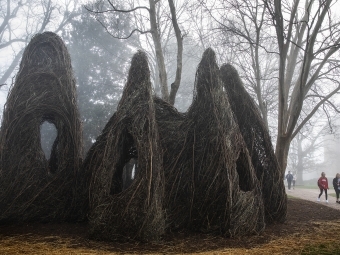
[0,32,287,241]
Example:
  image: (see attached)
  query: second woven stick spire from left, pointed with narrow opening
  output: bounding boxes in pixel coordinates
[84,52,165,241]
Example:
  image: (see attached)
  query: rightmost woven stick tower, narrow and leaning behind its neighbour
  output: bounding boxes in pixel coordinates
[221,64,287,223]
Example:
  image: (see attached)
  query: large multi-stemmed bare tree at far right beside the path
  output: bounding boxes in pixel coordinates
[264,0,340,171]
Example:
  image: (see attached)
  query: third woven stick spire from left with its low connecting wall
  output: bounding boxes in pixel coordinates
[155,49,265,236]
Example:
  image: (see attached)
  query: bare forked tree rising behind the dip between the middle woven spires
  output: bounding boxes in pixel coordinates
[87,0,186,105]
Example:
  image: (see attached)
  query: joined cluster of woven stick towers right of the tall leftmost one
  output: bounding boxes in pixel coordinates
[84,49,286,240]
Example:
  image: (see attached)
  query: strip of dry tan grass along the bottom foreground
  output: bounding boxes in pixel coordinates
[0,220,340,255]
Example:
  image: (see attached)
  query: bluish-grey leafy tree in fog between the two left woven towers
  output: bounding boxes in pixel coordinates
[63,8,134,151]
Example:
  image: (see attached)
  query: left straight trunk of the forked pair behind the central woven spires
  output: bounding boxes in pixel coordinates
[149,0,169,102]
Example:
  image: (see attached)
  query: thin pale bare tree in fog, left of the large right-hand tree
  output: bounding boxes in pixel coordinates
[195,0,277,128]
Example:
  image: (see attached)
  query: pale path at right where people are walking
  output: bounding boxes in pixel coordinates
[286,187,340,210]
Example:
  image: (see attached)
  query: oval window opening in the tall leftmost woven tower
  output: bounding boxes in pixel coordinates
[40,121,57,160]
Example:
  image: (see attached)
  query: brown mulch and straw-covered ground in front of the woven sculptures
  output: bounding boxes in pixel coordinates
[0,198,340,254]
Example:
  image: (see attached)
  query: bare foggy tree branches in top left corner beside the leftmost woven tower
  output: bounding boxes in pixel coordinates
[0,0,78,84]
